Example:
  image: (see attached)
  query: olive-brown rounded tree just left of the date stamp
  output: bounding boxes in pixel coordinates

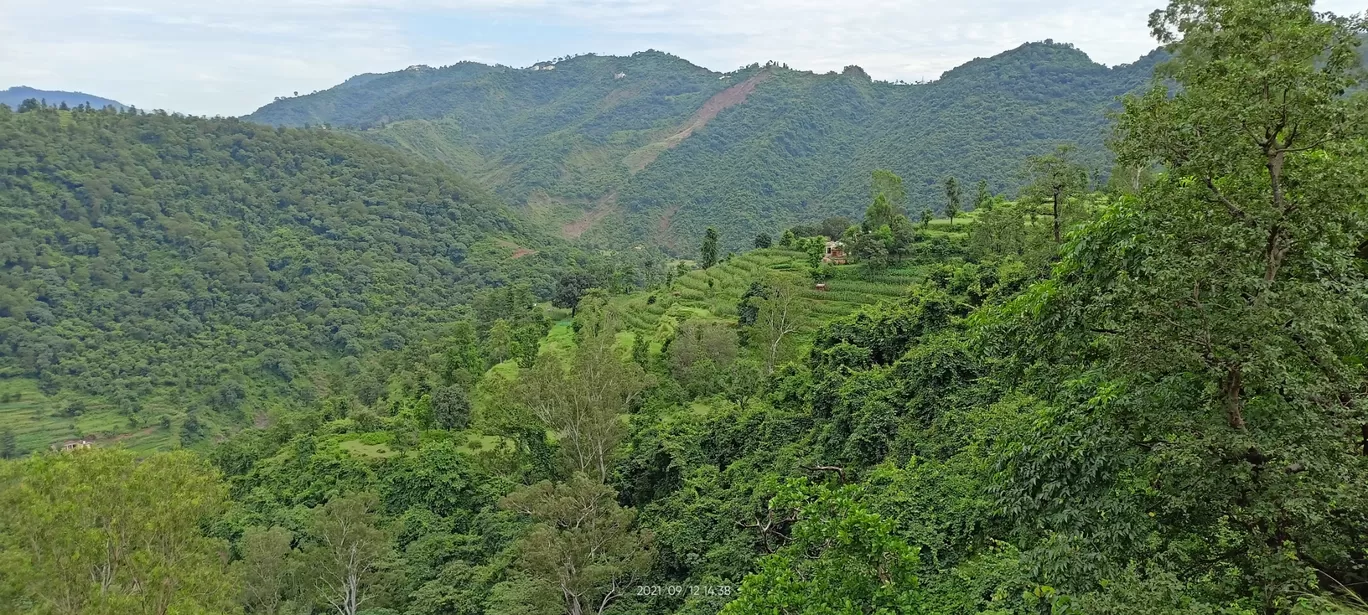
[499,473,653,615]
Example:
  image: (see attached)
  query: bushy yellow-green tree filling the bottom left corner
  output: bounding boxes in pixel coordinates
[0,448,241,615]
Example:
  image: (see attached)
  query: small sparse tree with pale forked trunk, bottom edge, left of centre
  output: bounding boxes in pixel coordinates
[304,493,390,615]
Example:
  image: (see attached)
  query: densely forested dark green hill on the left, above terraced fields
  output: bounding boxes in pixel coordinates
[0,107,564,432]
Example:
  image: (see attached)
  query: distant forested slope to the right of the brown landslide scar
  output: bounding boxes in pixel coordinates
[621,45,1157,249]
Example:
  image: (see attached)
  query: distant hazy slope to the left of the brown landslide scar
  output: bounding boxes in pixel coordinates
[248,52,731,213]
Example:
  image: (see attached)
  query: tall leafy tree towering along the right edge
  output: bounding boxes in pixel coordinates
[1005,0,1368,604]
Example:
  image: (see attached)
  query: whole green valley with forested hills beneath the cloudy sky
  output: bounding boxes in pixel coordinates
[0,0,1368,615]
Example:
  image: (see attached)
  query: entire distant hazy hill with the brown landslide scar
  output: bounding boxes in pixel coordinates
[248,41,1159,254]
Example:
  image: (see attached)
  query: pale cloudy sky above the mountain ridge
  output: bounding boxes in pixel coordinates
[0,0,1368,115]
